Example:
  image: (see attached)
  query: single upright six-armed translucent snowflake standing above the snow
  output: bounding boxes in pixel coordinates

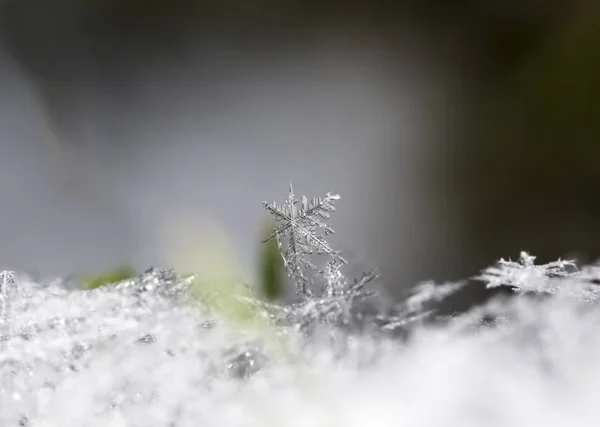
[263,184,346,297]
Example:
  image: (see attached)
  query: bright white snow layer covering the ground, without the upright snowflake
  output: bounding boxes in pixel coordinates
[0,254,600,427]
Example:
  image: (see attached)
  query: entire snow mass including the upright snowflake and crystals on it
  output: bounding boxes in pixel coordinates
[0,189,600,427]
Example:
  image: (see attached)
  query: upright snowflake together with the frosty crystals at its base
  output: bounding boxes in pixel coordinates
[259,184,390,335]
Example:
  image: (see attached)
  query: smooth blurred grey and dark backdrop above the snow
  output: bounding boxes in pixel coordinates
[0,0,600,296]
